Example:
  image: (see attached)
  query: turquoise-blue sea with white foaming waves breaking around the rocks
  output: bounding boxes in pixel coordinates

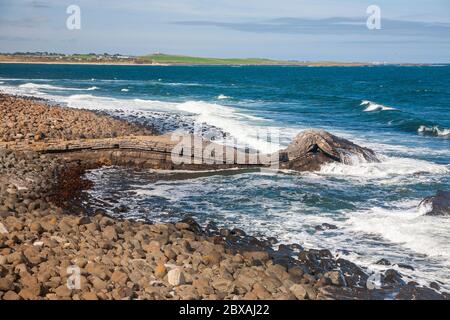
[0,64,450,288]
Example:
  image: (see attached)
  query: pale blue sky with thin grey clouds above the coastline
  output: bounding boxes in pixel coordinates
[0,0,450,63]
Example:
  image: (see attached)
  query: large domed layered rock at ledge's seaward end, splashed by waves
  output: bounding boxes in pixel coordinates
[280,129,379,171]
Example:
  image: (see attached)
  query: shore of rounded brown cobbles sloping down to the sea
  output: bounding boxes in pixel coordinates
[0,95,448,300]
